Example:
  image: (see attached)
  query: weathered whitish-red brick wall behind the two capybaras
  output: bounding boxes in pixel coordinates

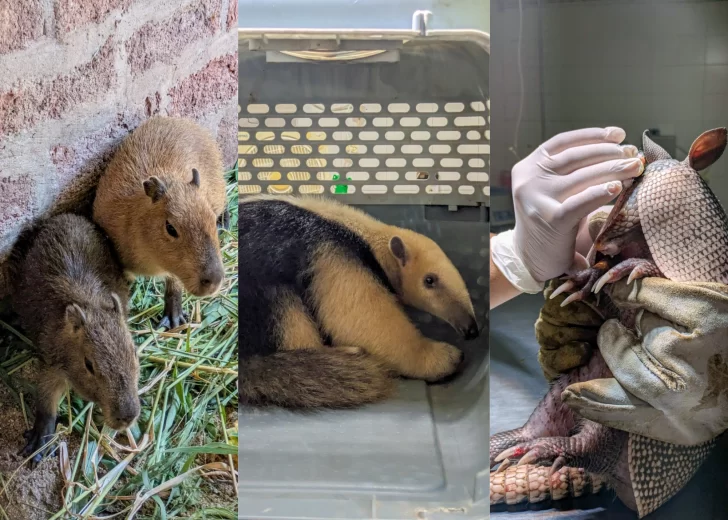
[0,0,238,295]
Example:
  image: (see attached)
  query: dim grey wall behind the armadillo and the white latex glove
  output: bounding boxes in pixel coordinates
[490,0,728,209]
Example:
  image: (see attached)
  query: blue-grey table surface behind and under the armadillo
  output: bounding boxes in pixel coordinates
[489,294,728,520]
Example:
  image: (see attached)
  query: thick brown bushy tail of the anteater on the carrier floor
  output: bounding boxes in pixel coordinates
[240,347,396,409]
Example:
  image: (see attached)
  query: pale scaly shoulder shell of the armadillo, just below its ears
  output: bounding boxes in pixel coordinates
[637,159,728,283]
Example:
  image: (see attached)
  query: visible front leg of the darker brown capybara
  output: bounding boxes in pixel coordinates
[20,368,66,465]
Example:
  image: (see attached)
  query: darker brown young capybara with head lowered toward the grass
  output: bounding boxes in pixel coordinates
[10,215,139,460]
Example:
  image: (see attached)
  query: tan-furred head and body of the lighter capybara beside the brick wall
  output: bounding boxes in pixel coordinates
[93,116,225,296]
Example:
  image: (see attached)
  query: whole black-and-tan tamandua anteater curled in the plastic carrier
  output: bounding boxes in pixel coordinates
[239,196,478,408]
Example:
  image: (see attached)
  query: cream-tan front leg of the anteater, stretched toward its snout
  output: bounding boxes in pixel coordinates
[311,255,463,381]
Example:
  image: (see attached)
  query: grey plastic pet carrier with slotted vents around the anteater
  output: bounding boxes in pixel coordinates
[238,3,490,520]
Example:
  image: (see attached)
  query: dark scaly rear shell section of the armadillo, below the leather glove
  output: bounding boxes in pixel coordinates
[628,433,716,518]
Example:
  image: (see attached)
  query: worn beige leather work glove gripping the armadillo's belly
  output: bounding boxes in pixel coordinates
[562,278,728,445]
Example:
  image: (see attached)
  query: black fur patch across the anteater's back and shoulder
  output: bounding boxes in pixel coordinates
[238,200,394,360]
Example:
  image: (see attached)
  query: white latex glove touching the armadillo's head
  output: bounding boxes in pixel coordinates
[491,127,644,293]
